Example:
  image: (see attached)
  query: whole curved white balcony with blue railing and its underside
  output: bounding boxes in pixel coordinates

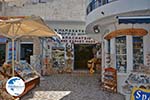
[86,0,150,33]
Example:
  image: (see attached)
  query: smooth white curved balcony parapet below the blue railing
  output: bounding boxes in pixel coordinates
[86,0,150,25]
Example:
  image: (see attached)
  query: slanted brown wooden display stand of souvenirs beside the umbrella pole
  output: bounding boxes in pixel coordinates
[15,62,40,97]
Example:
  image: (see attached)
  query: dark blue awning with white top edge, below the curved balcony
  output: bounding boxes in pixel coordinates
[117,16,150,24]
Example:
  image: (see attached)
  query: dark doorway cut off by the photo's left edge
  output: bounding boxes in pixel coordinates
[0,44,6,66]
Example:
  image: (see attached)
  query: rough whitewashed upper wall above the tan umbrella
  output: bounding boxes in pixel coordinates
[6,0,86,21]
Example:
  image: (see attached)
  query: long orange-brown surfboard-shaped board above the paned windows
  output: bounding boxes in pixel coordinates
[104,28,148,40]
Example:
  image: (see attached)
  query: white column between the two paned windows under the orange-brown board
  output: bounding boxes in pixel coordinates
[126,35,133,73]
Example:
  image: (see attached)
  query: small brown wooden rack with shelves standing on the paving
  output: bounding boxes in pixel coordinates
[102,67,117,93]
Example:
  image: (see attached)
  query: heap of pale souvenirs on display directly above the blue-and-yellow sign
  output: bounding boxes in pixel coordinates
[122,66,150,94]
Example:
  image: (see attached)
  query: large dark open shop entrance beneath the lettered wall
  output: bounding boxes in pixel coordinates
[74,44,95,70]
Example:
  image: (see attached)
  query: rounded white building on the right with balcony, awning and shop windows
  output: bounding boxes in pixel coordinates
[86,0,150,100]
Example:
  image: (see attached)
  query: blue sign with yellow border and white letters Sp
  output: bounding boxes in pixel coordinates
[131,87,150,100]
